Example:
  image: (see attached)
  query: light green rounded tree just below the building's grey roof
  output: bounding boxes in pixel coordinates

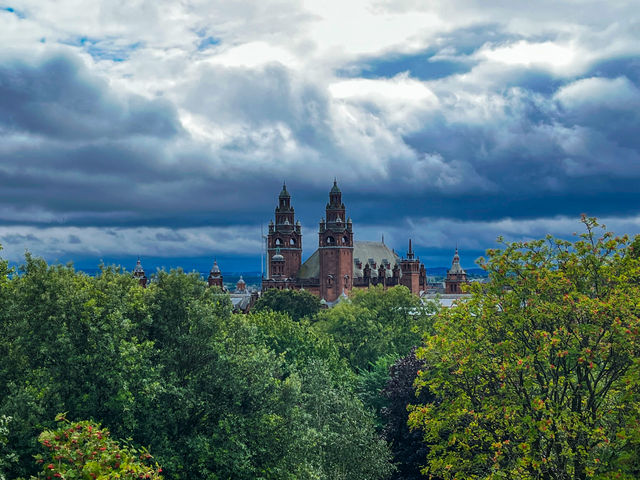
[314,286,436,370]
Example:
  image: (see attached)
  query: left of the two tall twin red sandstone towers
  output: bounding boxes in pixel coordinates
[267,184,302,279]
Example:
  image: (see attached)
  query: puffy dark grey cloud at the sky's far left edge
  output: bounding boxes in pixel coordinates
[0,54,181,141]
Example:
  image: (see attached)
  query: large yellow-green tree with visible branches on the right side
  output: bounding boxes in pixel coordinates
[410,218,640,479]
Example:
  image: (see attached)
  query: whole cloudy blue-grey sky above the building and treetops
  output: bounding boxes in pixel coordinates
[0,0,640,271]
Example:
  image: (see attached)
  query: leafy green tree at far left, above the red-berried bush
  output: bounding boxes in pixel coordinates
[0,255,154,476]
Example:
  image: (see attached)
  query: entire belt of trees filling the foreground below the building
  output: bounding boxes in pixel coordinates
[0,218,640,480]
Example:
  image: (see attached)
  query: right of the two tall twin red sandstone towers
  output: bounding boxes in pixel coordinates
[318,180,353,302]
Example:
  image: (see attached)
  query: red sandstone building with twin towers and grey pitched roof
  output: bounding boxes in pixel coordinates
[262,181,467,304]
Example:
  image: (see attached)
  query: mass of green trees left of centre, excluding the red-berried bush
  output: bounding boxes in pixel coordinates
[0,255,392,480]
